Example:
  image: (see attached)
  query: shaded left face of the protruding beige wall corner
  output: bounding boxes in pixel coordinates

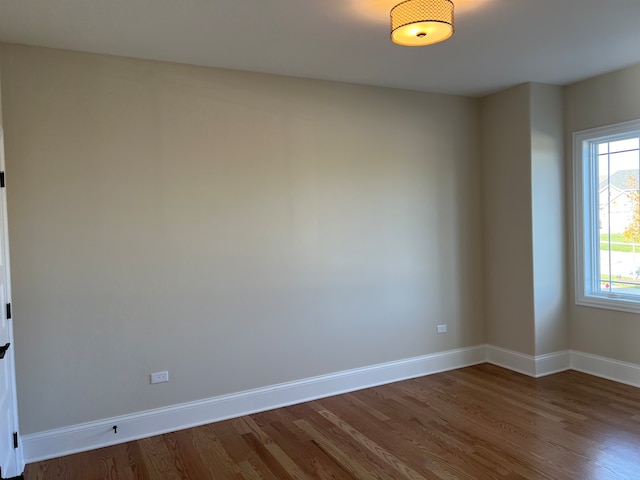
[481,85,535,355]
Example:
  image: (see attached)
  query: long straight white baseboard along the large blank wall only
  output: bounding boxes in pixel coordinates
[22,345,486,463]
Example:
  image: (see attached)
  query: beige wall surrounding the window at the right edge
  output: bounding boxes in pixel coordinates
[565,65,640,364]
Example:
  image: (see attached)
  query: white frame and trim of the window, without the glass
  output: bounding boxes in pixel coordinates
[573,120,640,313]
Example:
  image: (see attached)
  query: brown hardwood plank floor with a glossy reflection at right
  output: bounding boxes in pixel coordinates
[25,364,640,480]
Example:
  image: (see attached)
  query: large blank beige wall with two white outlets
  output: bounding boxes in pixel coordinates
[2,46,484,434]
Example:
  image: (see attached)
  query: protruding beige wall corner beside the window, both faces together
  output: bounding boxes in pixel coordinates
[481,83,568,356]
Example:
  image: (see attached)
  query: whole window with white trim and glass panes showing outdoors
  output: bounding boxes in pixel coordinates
[574,120,640,313]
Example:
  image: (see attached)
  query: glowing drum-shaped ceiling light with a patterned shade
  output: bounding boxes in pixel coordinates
[391,0,453,47]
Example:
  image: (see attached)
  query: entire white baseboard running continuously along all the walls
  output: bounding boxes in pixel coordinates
[21,345,640,463]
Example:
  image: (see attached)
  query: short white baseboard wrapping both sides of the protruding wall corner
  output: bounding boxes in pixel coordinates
[487,345,571,378]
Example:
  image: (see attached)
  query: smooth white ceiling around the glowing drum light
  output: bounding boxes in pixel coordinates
[0,0,640,96]
